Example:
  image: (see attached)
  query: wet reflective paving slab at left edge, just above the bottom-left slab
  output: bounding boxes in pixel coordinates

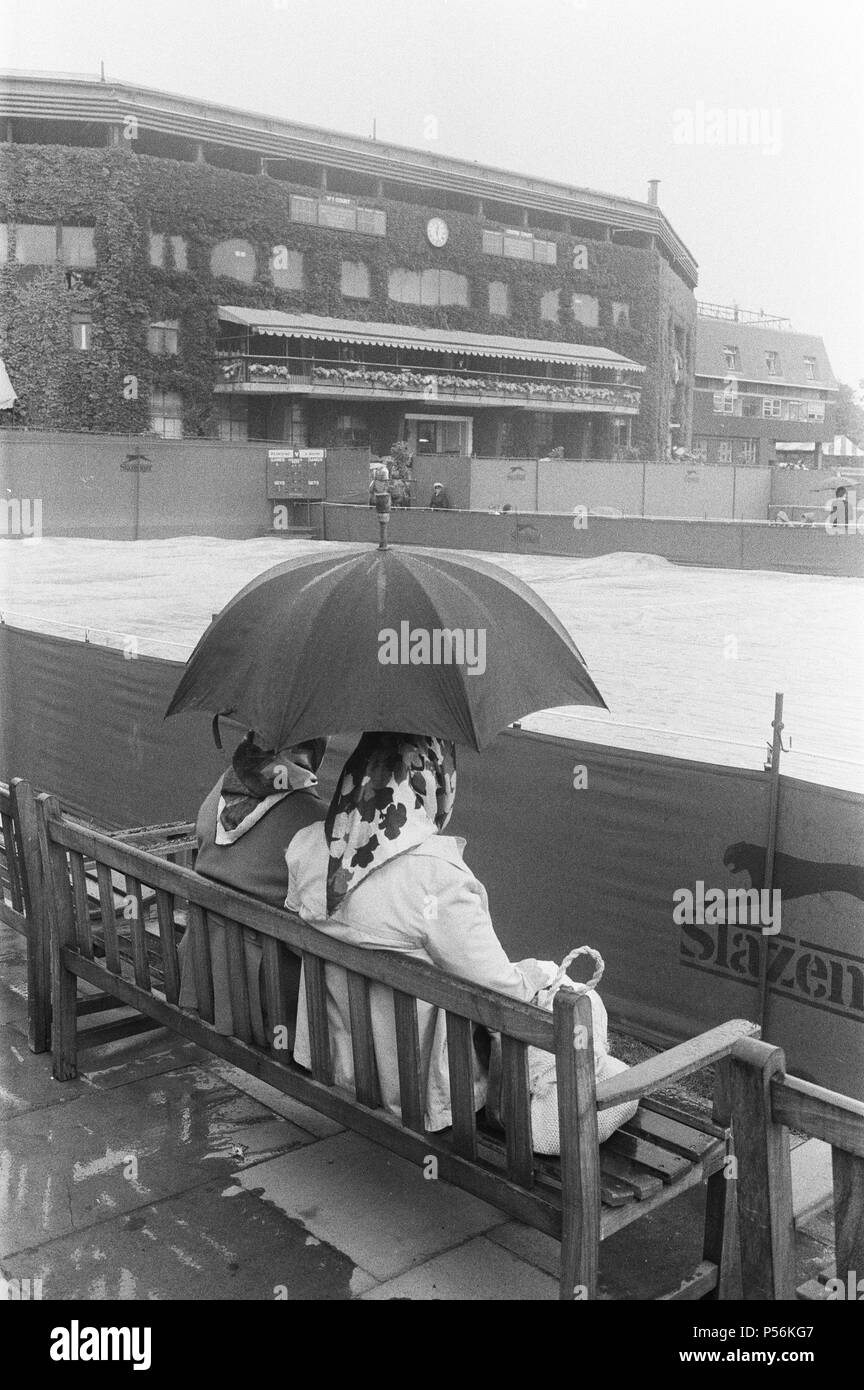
[0,1068,314,1254]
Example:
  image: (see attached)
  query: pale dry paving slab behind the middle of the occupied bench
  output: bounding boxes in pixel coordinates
[238,1131,501,1280]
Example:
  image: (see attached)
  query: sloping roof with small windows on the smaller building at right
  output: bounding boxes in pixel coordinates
[696,314,838,391]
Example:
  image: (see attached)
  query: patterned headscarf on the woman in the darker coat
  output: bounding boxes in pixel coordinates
[215,730,326,845]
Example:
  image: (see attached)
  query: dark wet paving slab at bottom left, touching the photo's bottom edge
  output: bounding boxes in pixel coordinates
[0,1182,374,1295]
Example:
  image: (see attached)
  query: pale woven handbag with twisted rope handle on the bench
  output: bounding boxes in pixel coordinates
[486,947,639,1154]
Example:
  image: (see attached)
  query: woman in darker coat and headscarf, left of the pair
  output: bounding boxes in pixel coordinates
[179,730,326,1045]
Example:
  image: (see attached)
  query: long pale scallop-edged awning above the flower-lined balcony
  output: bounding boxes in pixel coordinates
[219,304,645,371]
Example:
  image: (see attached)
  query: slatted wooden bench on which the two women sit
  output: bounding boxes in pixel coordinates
[39,796,757,1300]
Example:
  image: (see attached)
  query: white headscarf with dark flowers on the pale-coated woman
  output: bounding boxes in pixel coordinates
[324,733,456,917]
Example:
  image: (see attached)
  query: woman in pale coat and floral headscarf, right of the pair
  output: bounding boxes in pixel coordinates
[285,733,545,1130]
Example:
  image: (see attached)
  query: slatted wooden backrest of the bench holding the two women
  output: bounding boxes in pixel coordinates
[40,798,597,1234]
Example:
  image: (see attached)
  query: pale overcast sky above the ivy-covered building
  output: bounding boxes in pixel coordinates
[6,0,864,382]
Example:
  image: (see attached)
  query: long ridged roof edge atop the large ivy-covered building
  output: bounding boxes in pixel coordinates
[0,70,699,285]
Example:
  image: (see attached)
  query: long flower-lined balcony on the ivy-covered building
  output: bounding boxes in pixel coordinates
[215,352,640,416]
